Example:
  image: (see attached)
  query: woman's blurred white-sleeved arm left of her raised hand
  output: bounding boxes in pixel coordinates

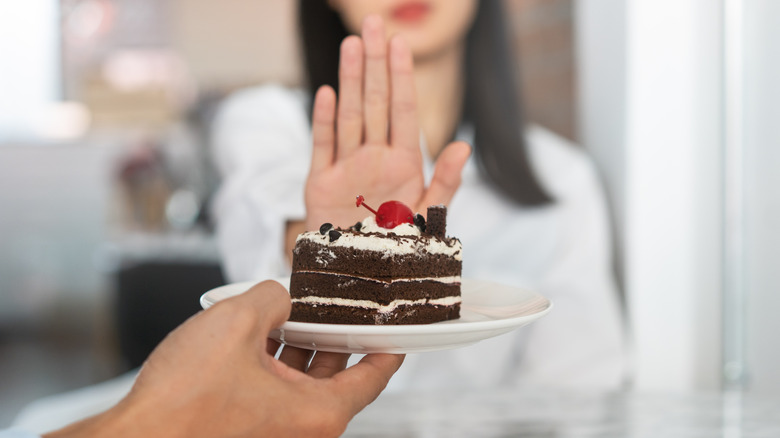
[212,86,311,281]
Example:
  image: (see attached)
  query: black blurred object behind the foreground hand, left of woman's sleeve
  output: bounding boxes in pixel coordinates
[116,262,225,370]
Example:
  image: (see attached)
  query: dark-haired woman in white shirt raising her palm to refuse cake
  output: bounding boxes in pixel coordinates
[214,0,624,389]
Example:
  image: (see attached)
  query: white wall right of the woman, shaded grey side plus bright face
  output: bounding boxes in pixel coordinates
[577,0,721,391]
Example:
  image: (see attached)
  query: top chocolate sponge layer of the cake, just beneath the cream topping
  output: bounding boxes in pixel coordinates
[293,240,462,278]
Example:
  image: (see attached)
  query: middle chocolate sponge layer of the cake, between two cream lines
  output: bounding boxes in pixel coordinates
[290,272,460,305]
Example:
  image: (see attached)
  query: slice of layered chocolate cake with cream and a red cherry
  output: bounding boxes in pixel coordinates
[290,199,462,324]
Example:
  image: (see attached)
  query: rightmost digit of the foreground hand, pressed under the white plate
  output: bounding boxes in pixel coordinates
[332,354,405,416]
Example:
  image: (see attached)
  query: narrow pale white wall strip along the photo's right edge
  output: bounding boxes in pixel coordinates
[744,0,780,394]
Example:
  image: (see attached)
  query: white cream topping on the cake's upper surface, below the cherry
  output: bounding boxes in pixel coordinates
[298,218,463,260]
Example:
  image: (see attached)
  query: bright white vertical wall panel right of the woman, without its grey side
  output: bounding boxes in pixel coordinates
[625,0,721,389]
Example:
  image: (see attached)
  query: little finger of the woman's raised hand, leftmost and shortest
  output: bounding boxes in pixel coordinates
[311,85,336,173]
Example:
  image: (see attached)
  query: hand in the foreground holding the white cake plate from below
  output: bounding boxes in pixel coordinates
[45,281,404,437]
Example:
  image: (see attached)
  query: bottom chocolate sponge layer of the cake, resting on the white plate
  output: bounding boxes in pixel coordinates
[290,303,460,325]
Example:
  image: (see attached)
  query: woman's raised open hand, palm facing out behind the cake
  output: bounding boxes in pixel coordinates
[306,16,471,230]
